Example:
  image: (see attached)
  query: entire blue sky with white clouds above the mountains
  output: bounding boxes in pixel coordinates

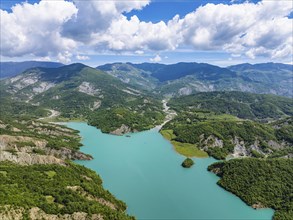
[0,0,293,67]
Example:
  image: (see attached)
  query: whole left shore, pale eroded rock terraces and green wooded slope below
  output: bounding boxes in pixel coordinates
[0,115,133,220]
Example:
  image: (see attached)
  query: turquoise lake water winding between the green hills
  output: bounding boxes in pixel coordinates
[66,122,273,220]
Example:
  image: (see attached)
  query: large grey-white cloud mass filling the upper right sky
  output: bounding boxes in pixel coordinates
[178,1,293,58]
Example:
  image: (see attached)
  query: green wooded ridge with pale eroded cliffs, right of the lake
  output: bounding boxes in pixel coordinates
[161,109,293,159]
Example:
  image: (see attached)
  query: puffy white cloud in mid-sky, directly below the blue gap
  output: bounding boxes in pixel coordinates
[92,16,177,51]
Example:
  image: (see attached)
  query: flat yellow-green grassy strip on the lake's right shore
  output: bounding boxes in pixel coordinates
[160,130,208,157]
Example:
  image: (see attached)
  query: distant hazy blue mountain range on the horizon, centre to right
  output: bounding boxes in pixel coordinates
[97,63,293,97]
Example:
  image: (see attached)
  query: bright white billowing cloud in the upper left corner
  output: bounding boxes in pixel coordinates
[0,0,77,57]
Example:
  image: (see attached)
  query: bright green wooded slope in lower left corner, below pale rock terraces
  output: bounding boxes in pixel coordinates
[0,162,133,220]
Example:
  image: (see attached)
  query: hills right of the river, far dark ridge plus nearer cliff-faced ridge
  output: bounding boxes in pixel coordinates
[160,92,293,159]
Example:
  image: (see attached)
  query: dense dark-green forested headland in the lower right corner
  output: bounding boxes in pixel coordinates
[208,158,293,220]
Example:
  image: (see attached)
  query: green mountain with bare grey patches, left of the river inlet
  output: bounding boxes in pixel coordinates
[1,63,164,134]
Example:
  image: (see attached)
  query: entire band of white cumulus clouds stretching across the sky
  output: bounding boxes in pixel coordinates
[0,0,293,62]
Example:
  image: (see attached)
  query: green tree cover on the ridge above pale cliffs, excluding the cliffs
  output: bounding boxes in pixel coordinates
[161,109,280,159]
